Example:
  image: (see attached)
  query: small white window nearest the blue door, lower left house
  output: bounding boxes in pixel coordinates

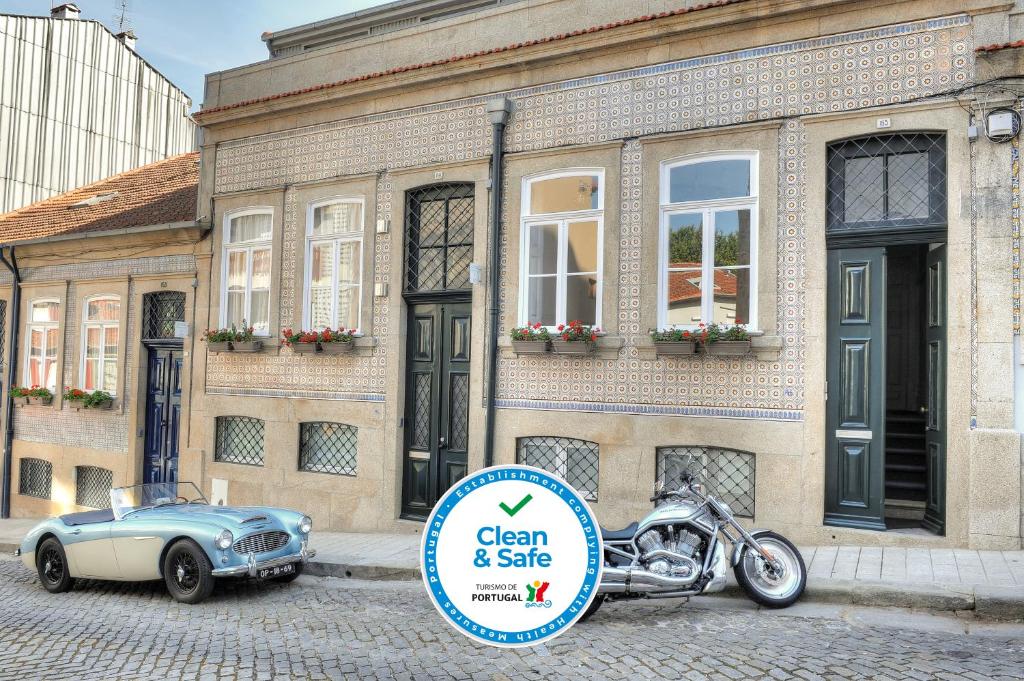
[82,295,121,395]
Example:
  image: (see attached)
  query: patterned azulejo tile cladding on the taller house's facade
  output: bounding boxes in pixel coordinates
[209,15,974,417]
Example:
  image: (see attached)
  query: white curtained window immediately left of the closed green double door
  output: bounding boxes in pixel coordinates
[303,198,365,330]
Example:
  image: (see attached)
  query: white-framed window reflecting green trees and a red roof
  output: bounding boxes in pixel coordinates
[657,152,758,330]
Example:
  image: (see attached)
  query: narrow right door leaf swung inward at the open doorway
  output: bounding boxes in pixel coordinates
[923,246,946,535]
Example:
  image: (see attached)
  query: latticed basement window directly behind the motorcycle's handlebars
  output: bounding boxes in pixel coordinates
[656,446,756,518]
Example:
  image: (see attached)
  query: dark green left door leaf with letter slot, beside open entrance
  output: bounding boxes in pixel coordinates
[824,248,886,529]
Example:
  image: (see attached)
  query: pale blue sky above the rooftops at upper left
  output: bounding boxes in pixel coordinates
[0,0,393,111]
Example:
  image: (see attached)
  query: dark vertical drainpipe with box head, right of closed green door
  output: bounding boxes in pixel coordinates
[483,97,512,467]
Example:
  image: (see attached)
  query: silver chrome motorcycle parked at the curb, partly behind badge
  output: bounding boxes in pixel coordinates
[582,473,807,620]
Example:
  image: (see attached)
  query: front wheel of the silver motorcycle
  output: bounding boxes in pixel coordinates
[733,530,807,607]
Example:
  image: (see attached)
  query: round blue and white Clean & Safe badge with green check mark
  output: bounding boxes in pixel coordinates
[421,466,603,647]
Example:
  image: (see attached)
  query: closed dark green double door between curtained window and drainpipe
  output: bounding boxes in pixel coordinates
[402,302,471,518]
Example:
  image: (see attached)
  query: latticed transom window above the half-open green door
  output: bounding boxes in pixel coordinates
[827,133,946,231]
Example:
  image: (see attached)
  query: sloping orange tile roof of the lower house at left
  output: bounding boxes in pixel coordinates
[0,152,199,244]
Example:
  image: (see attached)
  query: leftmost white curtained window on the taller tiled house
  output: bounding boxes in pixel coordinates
[220,208,273,336]
